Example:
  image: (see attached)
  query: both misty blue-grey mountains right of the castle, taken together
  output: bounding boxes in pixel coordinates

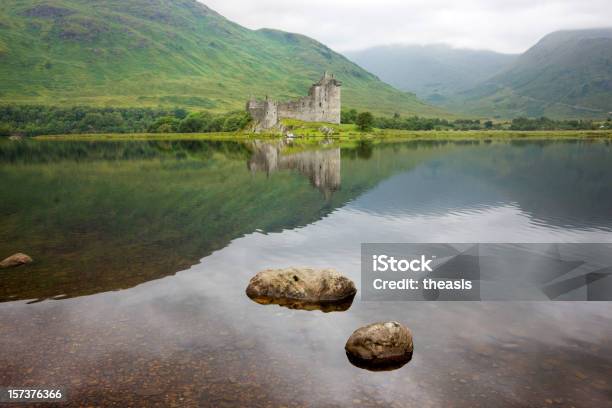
[349,28,612,118]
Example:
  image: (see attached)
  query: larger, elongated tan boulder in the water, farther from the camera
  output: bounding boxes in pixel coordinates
[246,268,357,312]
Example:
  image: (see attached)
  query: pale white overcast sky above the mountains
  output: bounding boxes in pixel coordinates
[201,0,612,53]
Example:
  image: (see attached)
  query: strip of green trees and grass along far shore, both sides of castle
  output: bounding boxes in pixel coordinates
[0,105,612,136]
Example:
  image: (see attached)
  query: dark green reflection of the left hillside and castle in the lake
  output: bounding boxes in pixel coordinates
[0,141,406,301]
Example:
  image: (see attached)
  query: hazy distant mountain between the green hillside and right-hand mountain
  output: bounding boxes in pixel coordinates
[346,44,517,104]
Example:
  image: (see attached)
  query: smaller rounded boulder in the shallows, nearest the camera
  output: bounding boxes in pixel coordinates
[344,322,413,371]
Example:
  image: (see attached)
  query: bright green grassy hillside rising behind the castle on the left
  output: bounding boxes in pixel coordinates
[0,0,440,115]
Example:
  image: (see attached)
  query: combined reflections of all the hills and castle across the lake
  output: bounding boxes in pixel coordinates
[0,141,612,301]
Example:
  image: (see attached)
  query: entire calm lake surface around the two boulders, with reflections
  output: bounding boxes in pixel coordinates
[0,141,612,407]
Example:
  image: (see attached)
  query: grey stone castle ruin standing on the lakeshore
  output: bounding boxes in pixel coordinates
[246,72,341,129]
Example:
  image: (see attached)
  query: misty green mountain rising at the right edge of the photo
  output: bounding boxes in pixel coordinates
[449,28,612,118]
